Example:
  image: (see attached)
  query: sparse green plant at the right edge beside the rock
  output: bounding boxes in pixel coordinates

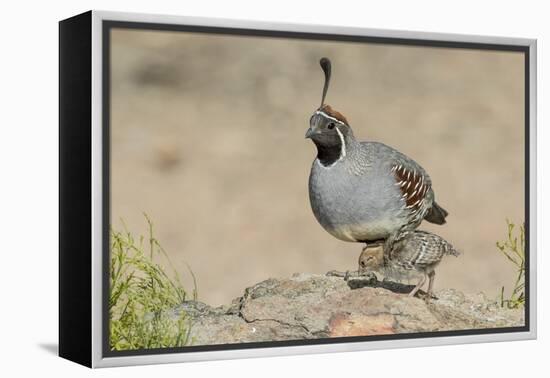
[496,219,525,308]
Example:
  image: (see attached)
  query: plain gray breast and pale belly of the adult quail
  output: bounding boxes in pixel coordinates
[309,160,407,242]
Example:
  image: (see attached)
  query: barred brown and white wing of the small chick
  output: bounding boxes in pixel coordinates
[390,231,460,270]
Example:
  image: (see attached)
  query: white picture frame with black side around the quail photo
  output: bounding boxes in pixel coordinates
[60,11,537,368]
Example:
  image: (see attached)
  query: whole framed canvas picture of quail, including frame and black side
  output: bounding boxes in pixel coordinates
[59,11,536,367]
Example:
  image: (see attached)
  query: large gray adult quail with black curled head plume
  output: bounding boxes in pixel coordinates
[306,58,448,245]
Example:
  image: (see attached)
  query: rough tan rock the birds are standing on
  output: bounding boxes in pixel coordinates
[172,272,524,345]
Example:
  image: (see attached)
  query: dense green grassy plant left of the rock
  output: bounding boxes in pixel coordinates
[109,214,197,350]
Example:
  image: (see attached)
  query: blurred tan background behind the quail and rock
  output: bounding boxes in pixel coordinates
[111,29,524,305]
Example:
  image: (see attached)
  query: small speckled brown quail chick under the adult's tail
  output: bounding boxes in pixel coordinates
[359,231,459,298]
